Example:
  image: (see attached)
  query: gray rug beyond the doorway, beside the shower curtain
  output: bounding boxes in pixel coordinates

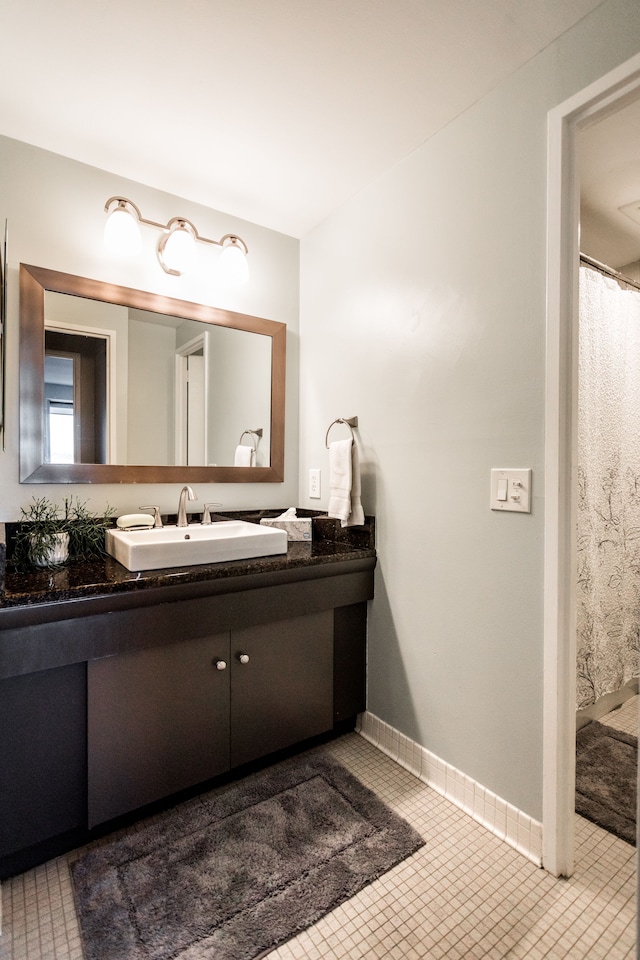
[576,720,638,845]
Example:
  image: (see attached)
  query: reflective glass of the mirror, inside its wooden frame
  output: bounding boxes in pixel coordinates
[43,291,271,467]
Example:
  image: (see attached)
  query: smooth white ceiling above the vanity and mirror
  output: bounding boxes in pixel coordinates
[0,0,601,237]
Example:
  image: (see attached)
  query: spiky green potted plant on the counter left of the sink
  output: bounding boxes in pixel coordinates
[13,497,114,568]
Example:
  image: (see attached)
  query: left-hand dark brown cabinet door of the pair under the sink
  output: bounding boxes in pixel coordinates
[88,634,229,826]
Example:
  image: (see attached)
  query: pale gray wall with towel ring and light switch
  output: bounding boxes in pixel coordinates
[300,0,640,820]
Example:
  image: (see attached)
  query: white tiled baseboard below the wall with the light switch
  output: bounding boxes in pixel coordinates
[356,711,542,866]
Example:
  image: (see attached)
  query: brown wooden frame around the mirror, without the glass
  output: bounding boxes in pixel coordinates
[20,263,287,483]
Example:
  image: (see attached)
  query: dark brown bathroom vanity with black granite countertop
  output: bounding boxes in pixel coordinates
[0,516,376,878]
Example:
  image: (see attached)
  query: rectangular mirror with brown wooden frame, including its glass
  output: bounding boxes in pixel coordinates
[20,264,286,483]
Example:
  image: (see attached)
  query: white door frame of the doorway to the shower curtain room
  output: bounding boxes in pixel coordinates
[542,54,640,877]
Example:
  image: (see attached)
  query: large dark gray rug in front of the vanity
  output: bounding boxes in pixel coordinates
[71,753,424,960]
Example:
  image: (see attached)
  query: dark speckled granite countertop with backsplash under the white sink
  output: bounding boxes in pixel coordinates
[0,509,376,608]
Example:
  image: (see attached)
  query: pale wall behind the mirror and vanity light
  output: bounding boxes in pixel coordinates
[0,137,299,520]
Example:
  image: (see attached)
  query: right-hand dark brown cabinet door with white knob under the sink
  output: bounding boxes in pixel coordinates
[231,610,333,767]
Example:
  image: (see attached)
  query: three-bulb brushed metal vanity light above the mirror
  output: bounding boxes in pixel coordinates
[104,197,249,283]
